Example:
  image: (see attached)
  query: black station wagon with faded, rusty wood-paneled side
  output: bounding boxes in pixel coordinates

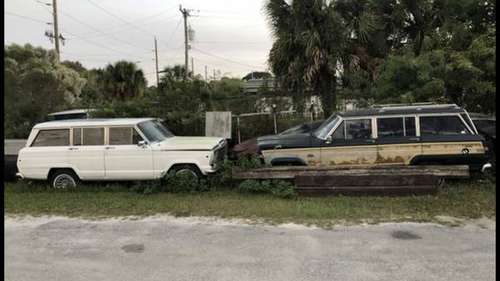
[257,104,491,171]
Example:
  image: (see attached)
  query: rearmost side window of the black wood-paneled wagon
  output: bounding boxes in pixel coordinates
[420,116,470,136]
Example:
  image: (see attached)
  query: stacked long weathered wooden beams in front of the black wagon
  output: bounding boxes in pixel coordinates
[233,166,469,194]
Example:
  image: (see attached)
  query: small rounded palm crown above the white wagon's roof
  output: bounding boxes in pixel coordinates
[100,61,146,100]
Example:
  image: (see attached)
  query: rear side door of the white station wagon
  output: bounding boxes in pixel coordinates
[69,127,105,180]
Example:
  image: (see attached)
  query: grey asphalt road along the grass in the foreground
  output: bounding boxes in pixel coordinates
[5,216,495,281]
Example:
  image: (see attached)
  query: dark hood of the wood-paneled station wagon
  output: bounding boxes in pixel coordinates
[257,133,315,150]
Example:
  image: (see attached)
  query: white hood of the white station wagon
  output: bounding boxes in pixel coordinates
[160,137,224,150]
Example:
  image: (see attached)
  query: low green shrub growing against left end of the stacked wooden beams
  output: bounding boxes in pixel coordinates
[238,180,297,198]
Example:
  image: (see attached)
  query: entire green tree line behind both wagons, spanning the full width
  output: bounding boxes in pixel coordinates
[4,0,496,138]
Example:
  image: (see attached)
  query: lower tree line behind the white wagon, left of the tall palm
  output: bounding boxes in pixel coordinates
[4,44,269,138]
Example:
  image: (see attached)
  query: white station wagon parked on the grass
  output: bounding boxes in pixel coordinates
[17,118,227,188]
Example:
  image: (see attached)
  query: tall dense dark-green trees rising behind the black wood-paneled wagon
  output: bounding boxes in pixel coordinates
[265,0,496,115]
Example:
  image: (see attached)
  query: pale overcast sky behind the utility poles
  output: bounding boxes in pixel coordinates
[4,0,272,85]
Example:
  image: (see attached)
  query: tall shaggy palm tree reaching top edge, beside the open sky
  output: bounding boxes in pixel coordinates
[265,0,348,116]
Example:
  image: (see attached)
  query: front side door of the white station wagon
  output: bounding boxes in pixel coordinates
[104,126,153,180]
